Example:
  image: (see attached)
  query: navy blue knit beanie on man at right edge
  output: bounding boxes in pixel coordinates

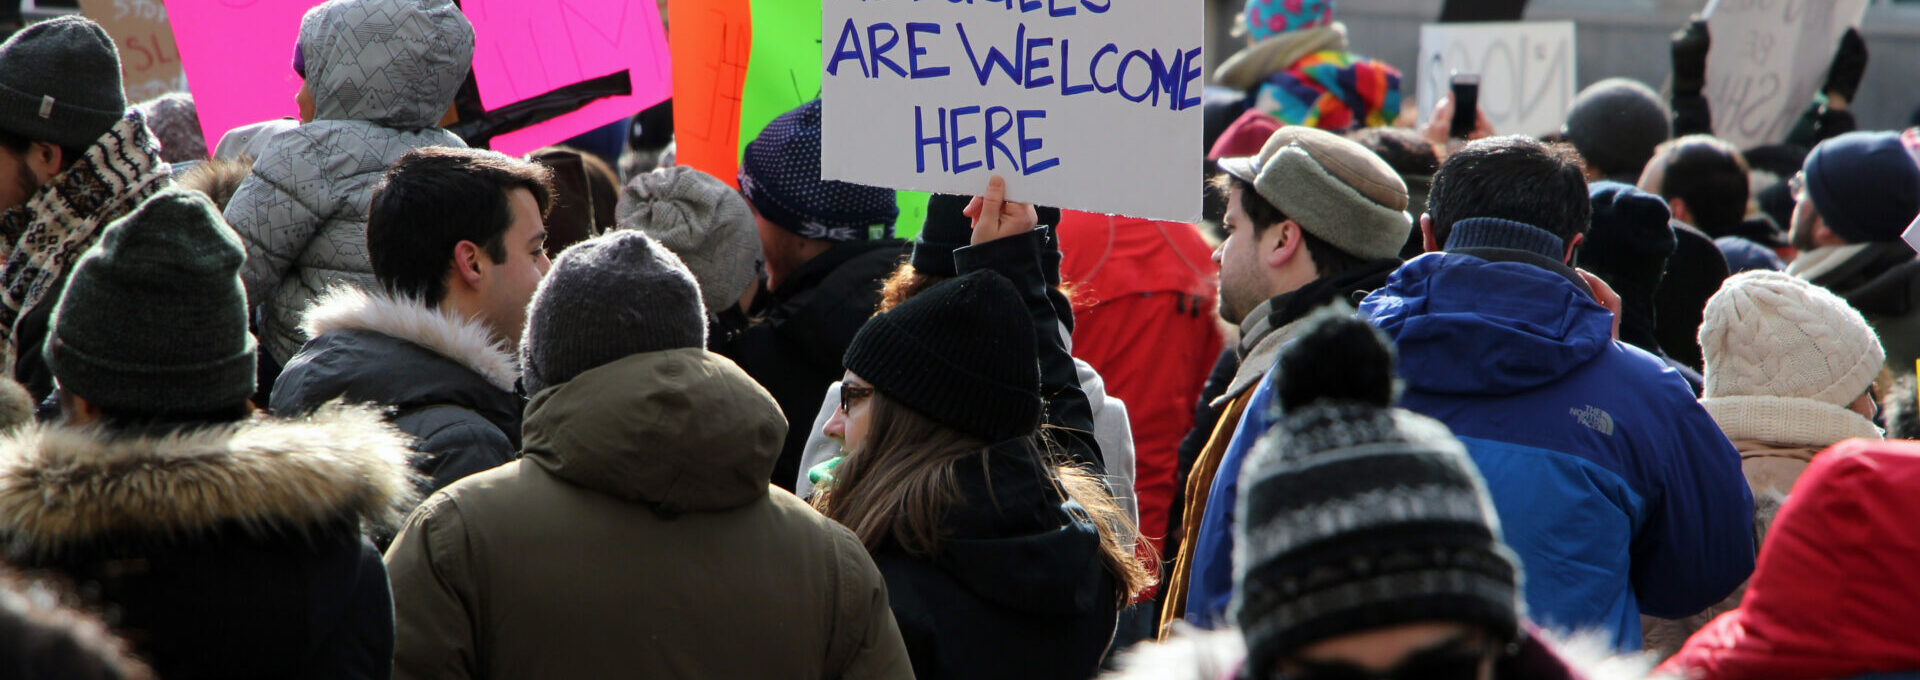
[1805,133,1920,244]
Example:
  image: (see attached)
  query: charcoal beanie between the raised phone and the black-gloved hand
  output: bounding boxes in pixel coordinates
[1565,79,1674,184]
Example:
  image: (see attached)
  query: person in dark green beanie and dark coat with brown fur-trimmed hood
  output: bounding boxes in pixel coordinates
[0,190,413,678]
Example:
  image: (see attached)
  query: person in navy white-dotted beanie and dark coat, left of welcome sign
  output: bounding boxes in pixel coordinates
[714,100,906,485]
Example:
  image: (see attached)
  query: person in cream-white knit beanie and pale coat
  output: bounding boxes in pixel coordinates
[1644,271,1885,655]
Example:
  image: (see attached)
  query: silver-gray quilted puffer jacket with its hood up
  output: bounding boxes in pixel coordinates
[227,0,474,363]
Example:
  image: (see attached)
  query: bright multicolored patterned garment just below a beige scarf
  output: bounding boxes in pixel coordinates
[1254,50,1400,133]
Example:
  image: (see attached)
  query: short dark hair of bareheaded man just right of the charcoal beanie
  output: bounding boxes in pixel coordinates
[1655,134,1751,238]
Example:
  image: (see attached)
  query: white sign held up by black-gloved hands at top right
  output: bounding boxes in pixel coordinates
[1705,0,1868,148]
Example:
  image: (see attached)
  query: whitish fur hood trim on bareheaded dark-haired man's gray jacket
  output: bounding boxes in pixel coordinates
[301,286,520,392]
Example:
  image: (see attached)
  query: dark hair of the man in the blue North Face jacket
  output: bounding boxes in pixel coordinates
[1427,136,1594,246]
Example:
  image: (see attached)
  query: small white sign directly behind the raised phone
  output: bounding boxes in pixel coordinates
[1417,21,1576,134]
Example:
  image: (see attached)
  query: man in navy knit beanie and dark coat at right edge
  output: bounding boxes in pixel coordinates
[1788,133,1920,373]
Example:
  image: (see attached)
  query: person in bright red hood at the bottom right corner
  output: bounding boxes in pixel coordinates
[1659,440,1920,680]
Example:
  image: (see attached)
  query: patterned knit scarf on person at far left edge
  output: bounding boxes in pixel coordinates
[0,109,173,373]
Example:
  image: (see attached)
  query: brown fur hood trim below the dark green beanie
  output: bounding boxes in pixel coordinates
[0,403,417,555]
